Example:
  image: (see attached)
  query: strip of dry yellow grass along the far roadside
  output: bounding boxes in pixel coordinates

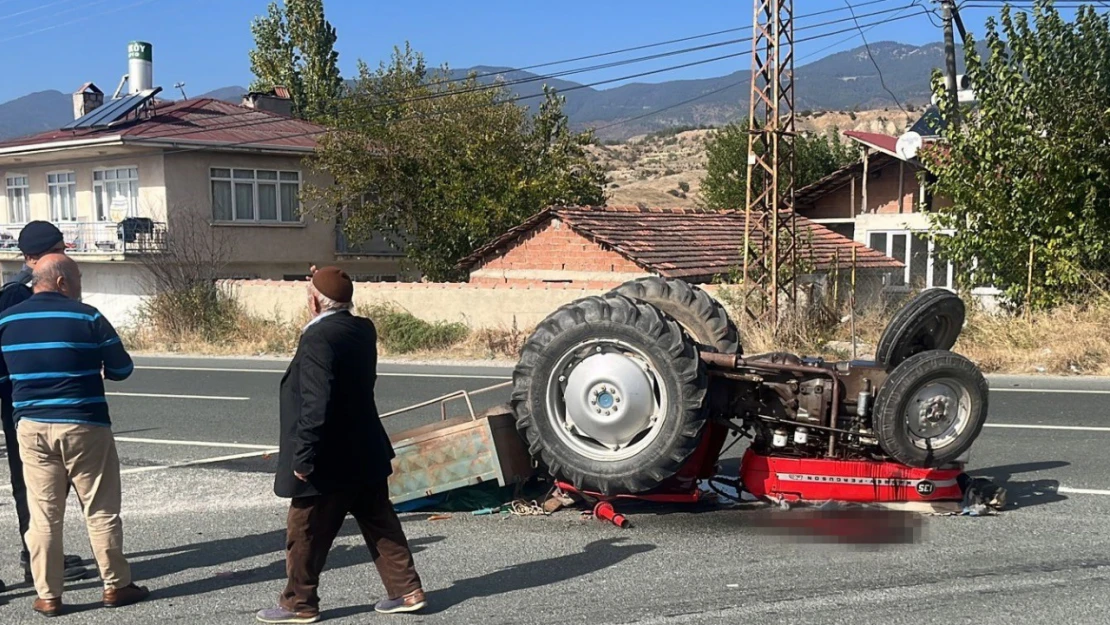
[121,290,1110,375]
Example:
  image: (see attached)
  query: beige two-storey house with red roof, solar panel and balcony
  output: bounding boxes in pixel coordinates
[0,83,403,322]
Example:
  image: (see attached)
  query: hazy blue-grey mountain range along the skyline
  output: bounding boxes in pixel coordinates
[0,41,972,140]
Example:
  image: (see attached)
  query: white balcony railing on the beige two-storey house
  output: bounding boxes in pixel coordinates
[0,218,167,254]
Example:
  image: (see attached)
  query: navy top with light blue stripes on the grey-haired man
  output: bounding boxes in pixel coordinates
[0,292,134,425]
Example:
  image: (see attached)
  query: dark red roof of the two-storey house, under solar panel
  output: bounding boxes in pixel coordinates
[0,98,324,150]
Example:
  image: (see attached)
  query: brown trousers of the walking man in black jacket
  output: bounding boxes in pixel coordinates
[279,482,421,614]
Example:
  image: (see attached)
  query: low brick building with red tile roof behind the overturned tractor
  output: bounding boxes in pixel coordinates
[458,206,904,306]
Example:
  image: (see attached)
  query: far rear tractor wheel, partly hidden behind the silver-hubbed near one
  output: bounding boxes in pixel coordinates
[614,275,743,354]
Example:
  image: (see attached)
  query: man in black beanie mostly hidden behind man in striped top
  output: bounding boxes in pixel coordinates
[0,221,88,591]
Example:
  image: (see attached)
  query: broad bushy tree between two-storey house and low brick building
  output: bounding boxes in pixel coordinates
[304,44,605,280]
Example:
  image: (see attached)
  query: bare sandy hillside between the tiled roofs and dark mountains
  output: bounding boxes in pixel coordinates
[591,109,919,208]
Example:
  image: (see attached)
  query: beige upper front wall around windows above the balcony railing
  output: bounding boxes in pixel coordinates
[0,150,165,223]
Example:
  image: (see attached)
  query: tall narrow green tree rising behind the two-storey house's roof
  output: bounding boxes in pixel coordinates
[249,0,343,121]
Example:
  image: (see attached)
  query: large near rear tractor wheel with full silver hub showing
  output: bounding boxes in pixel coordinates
[512,293,707,495]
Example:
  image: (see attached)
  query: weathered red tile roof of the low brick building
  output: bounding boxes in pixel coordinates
[460,206,904,282]
